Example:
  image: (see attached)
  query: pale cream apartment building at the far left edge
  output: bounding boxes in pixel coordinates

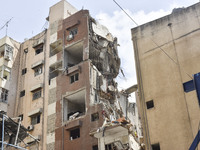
[0,36,20,112]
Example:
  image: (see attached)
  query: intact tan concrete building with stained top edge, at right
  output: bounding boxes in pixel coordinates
[132,3,200,150]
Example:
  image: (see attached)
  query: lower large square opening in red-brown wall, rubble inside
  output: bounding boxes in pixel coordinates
[63,90,85,121]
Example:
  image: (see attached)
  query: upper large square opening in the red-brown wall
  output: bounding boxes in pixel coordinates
[64,42,83,68]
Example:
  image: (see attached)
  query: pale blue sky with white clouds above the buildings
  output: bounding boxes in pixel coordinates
[0,0,199,102]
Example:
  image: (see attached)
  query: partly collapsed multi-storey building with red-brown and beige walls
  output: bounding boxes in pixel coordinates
[0,0,143,150]
